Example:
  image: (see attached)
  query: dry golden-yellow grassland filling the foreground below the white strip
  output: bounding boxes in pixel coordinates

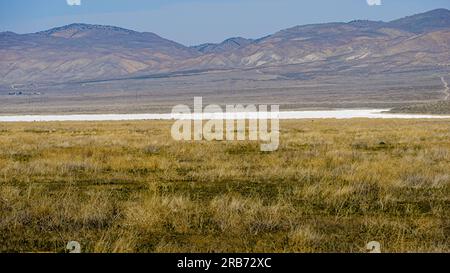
[0,120,450,252]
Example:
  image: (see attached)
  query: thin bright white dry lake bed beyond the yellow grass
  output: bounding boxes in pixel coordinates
[0,109,450,122]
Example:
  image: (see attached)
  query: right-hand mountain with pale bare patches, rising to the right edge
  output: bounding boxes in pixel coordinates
[192,10,450,71]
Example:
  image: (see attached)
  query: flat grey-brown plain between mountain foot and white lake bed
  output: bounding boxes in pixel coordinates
[0,68,450,115]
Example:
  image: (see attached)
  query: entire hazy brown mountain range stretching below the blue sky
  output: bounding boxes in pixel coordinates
[0,9,450,84]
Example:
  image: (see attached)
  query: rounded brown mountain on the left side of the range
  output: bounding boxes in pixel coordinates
[0,24,199,82]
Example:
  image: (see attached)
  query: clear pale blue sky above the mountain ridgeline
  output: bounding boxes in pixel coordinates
[0,0,450,45]
